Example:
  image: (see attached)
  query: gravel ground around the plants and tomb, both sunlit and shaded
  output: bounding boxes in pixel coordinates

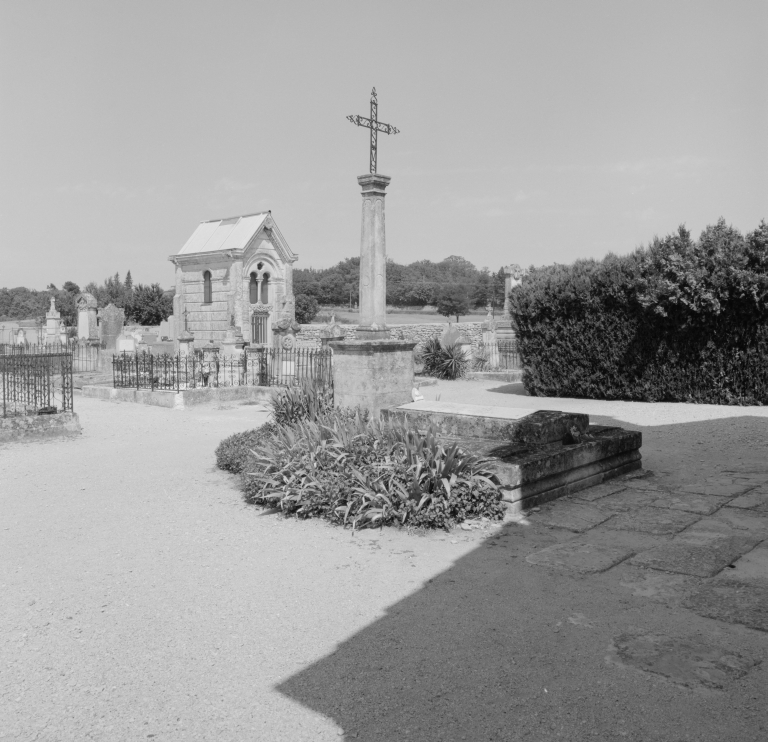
[0,390,768,742]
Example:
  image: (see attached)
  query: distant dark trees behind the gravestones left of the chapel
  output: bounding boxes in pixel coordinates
[0,271,174,327]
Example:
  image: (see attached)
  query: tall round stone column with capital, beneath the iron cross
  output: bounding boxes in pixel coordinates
[357,173,391,340]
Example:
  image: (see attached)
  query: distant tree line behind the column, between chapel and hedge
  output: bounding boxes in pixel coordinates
[293,255,504,316]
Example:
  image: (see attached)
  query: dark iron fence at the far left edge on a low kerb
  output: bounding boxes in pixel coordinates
[0,353,72,417]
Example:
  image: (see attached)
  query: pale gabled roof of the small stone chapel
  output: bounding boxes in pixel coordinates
[174,211,298,263]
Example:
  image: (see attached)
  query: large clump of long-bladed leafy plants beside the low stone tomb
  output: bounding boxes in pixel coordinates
[243,410,504,529]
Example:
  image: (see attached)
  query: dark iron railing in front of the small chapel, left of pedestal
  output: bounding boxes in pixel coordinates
[112,348,333,392]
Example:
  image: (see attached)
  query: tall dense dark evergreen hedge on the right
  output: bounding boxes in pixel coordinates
[510,219,768,404]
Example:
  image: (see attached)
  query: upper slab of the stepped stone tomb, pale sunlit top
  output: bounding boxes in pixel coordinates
[389,400,589,453]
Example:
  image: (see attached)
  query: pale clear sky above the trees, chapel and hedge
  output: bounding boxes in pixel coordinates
[0,0,768,289]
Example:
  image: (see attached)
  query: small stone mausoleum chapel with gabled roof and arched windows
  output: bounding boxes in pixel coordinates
[169,211,298,345]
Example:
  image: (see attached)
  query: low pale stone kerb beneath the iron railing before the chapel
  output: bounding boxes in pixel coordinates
[82,384,272,410]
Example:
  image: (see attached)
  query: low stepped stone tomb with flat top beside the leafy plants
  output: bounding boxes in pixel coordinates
[384,401,643,511]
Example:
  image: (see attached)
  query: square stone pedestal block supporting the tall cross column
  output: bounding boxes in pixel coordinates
[328,340,416,416]
